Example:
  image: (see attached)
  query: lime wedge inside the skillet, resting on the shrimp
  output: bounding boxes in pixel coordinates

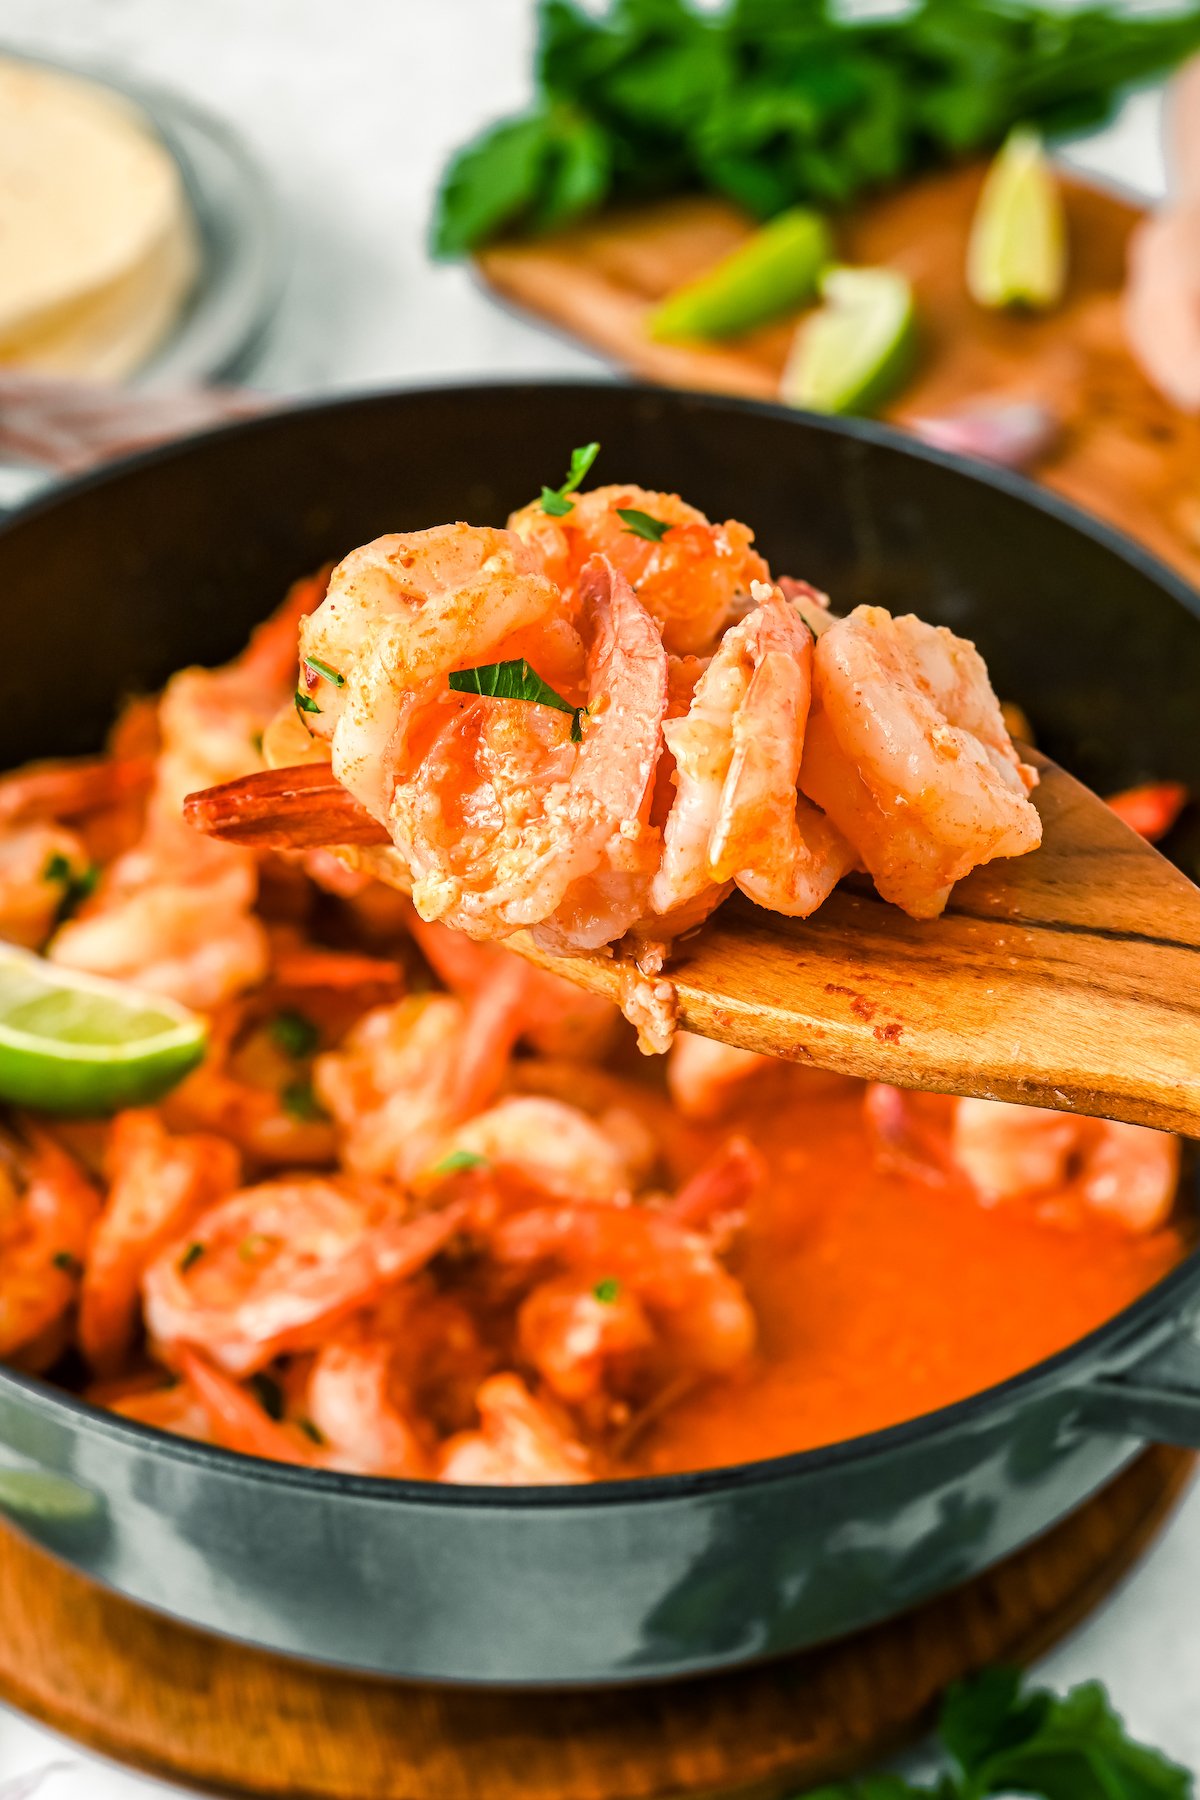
[0,943,207,1112]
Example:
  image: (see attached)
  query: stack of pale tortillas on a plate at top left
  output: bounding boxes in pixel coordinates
[0,58,198,380]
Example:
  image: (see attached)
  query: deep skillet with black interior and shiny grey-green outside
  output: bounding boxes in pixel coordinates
[0,385,1200,1685]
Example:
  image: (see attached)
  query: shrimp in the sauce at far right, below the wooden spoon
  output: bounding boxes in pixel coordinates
[952,1100,1180,1233]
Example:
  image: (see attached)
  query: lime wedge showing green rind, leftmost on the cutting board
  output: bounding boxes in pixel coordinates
[649,207,833,338]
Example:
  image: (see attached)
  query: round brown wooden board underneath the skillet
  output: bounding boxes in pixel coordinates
[0,1447,1195,1800]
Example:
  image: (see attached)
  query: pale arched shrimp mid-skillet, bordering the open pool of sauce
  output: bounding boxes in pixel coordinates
[425,1094,644,1201]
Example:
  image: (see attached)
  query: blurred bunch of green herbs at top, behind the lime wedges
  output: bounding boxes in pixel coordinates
[434,0,1200,256]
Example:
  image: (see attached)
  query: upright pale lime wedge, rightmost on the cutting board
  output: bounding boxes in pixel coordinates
[966,126,1067,306]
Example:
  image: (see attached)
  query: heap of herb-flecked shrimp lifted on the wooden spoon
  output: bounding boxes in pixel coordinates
[189,471,1040,1051]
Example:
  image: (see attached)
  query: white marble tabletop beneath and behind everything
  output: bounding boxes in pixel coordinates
[0,0,1200,1800]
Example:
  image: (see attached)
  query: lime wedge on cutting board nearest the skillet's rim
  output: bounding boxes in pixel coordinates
[781,268,916,412]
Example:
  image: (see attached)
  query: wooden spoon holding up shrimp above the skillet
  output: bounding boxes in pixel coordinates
[187,751,1200,1136]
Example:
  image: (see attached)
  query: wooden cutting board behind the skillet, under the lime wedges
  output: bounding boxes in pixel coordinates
[479,166,1200,585]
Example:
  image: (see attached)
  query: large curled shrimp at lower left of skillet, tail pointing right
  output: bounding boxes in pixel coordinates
[142,1175,461,1375]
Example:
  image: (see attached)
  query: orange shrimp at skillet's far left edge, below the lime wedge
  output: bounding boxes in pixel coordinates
[0,1127,101,1368]
